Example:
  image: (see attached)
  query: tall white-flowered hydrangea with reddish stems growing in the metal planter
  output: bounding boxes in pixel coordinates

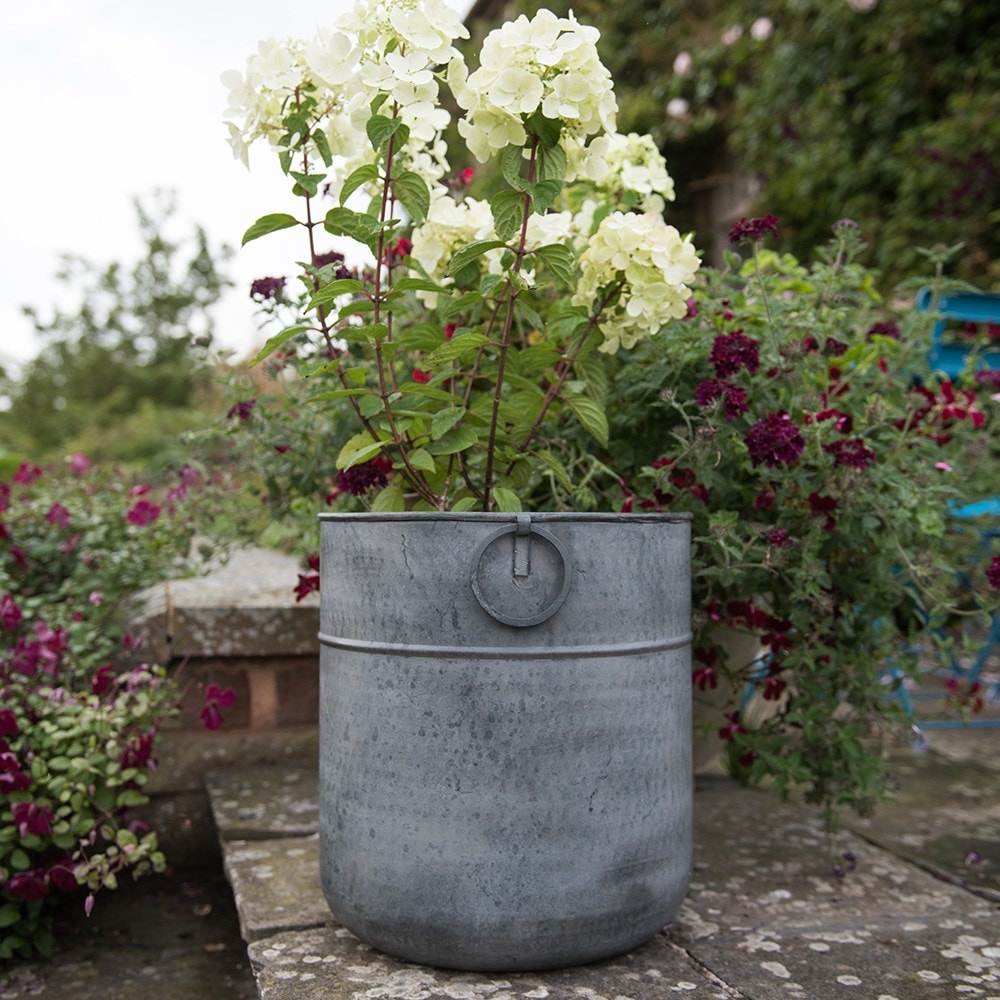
[224,0,698,510]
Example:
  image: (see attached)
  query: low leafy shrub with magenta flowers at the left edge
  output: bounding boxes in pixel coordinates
[0,455,231,959]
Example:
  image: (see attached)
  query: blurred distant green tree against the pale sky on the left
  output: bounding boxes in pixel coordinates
[0,188,230,463]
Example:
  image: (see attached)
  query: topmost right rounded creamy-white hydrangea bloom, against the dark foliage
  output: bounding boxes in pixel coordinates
[449,9,618,162]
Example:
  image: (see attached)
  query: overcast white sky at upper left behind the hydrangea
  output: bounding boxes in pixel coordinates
[0,0,394,376]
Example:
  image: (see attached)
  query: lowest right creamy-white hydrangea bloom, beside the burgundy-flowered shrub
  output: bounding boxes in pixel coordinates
[573,212,700,353]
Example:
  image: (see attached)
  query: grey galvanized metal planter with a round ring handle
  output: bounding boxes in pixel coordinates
[320,513,692,972]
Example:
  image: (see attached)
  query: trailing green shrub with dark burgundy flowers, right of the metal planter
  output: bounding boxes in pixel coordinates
[608,225,1000,819]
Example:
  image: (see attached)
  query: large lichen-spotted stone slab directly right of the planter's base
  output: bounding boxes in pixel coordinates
[670,779,1000,1000]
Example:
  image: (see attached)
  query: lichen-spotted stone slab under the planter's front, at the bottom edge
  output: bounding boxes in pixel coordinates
[248,924,744,1000]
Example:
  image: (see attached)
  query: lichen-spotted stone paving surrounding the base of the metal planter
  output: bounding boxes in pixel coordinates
[210,716,1000,1000]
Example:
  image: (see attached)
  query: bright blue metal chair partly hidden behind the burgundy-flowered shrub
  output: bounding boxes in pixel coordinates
[890,288,1000,736]
